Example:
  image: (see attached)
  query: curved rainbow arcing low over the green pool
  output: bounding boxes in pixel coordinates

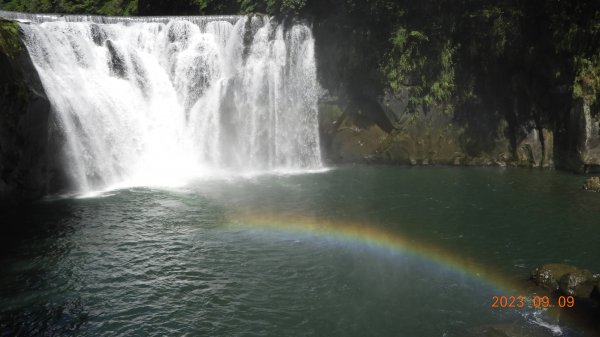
[227,214,524,295]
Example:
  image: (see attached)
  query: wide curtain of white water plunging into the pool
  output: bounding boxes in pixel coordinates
[10,11,322,191]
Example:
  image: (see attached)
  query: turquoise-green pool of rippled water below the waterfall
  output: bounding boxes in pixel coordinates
[0,166,600,336]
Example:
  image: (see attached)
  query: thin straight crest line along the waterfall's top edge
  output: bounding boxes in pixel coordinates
[0,10,243,24]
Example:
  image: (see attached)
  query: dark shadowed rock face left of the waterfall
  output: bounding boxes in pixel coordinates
[0,21,64,202]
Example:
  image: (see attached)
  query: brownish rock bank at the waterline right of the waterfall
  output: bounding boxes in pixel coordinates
[320,88,554,168]
